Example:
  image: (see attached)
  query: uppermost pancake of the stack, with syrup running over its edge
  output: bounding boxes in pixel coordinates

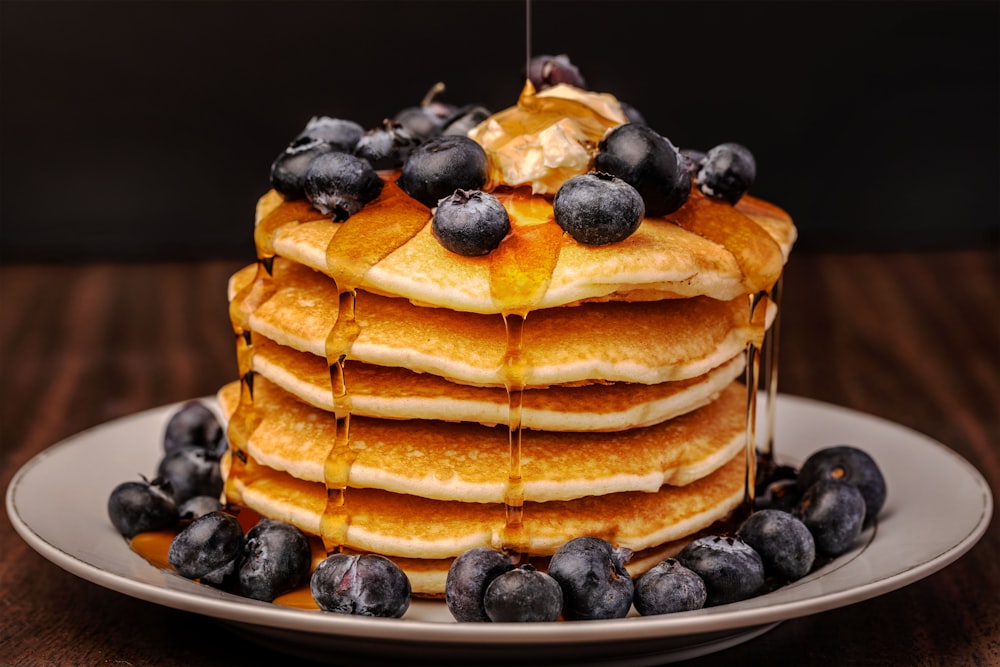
[256,174,796,313]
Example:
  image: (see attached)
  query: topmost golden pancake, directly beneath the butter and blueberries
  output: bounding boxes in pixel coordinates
[257,180,796,313]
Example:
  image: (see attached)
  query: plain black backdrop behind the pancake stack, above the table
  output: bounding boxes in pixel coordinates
[0,0,1000,261]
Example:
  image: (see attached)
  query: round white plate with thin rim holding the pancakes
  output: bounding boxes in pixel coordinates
[7,395,993,666]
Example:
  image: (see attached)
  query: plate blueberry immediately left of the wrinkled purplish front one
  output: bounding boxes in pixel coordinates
[239,519,312,602]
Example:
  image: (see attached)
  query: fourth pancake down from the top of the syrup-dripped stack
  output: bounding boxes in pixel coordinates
[219,378,746,503]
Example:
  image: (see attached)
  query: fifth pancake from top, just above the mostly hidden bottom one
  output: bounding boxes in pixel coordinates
[225,444,744,559]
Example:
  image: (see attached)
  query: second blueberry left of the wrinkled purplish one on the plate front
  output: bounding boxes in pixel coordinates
[167,512,243,579]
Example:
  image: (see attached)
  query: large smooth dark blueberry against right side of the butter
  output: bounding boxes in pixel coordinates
[594,123,691,215]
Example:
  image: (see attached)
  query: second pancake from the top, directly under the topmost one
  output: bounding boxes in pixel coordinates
[229,257,768,387]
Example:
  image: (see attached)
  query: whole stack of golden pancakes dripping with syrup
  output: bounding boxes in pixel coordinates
[219,109,795,596]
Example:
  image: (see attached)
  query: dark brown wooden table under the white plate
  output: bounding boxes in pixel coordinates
[0,251,1000,666]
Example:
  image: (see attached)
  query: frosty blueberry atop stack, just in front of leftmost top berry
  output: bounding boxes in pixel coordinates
[305,153,382,222]
